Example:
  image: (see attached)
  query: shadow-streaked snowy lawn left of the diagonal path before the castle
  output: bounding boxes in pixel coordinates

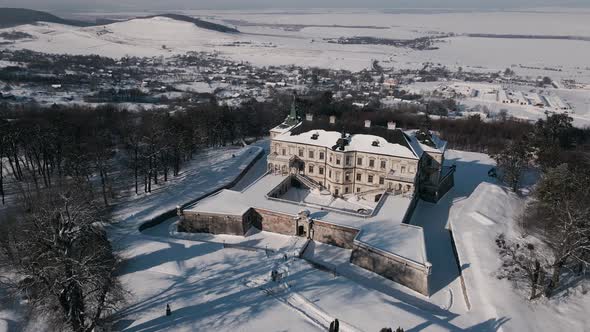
[115,231,318,331]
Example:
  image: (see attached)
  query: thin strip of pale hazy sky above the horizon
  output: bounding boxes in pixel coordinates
[0,0,590,12]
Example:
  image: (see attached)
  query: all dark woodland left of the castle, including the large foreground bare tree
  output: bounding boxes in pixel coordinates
[0,99,287,332]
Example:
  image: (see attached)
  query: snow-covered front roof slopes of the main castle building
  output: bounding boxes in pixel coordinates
[274,129,418,159]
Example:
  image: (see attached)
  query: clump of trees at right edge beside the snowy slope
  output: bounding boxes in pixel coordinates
[494,114,590,299]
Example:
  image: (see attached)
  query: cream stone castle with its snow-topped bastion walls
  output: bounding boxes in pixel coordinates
[177,109,454,295]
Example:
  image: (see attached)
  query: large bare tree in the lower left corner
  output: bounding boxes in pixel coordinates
[0,184,123,332]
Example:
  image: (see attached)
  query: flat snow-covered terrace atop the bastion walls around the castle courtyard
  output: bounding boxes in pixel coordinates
[185,174,428,264]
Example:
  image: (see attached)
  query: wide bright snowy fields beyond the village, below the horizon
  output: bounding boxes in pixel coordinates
[3,10,590,83]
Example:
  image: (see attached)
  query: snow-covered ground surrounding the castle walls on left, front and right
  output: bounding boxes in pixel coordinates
[0,137,590,331]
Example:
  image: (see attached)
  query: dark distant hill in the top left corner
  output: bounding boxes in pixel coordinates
[0,8,94,28]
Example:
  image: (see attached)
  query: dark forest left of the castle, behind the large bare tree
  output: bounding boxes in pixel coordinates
[0,99,287,205]
